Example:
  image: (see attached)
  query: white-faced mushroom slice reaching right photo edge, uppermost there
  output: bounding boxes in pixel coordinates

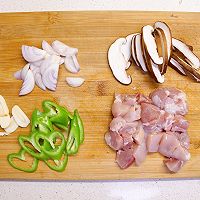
[172,38,200,69]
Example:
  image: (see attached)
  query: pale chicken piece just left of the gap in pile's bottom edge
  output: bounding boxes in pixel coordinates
[133,141,147,166]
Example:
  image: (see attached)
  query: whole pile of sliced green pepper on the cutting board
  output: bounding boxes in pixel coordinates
[8,101,84,172]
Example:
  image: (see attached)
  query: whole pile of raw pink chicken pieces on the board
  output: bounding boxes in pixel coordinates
[105,88,190,172]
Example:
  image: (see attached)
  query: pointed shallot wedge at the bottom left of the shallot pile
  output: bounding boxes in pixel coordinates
[19,69,35,96]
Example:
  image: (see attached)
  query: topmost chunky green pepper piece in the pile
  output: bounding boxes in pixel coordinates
[42,100,73,130]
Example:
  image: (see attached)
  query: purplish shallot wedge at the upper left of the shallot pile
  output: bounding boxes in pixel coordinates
[22,45,46,62]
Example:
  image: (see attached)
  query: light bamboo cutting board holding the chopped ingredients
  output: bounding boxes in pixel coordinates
[0,12,200,180]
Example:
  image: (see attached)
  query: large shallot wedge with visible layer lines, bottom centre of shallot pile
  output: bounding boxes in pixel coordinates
[42,63,59,91]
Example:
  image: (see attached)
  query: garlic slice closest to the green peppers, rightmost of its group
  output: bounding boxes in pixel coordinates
[12,105,30,128]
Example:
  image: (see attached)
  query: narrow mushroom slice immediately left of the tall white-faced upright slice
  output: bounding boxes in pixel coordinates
[134,34,147,72]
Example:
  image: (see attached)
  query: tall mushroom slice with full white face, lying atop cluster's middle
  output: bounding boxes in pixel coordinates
[142,25,163,65]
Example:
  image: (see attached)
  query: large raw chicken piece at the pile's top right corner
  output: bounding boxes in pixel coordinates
[149,88,188,115]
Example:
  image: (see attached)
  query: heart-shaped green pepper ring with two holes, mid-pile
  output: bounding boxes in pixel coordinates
[35,131,66,160]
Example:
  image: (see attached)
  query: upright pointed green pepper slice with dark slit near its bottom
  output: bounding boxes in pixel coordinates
[67,112,80,155]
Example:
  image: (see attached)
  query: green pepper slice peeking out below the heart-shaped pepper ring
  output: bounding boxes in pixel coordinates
[44,151,68,172]
